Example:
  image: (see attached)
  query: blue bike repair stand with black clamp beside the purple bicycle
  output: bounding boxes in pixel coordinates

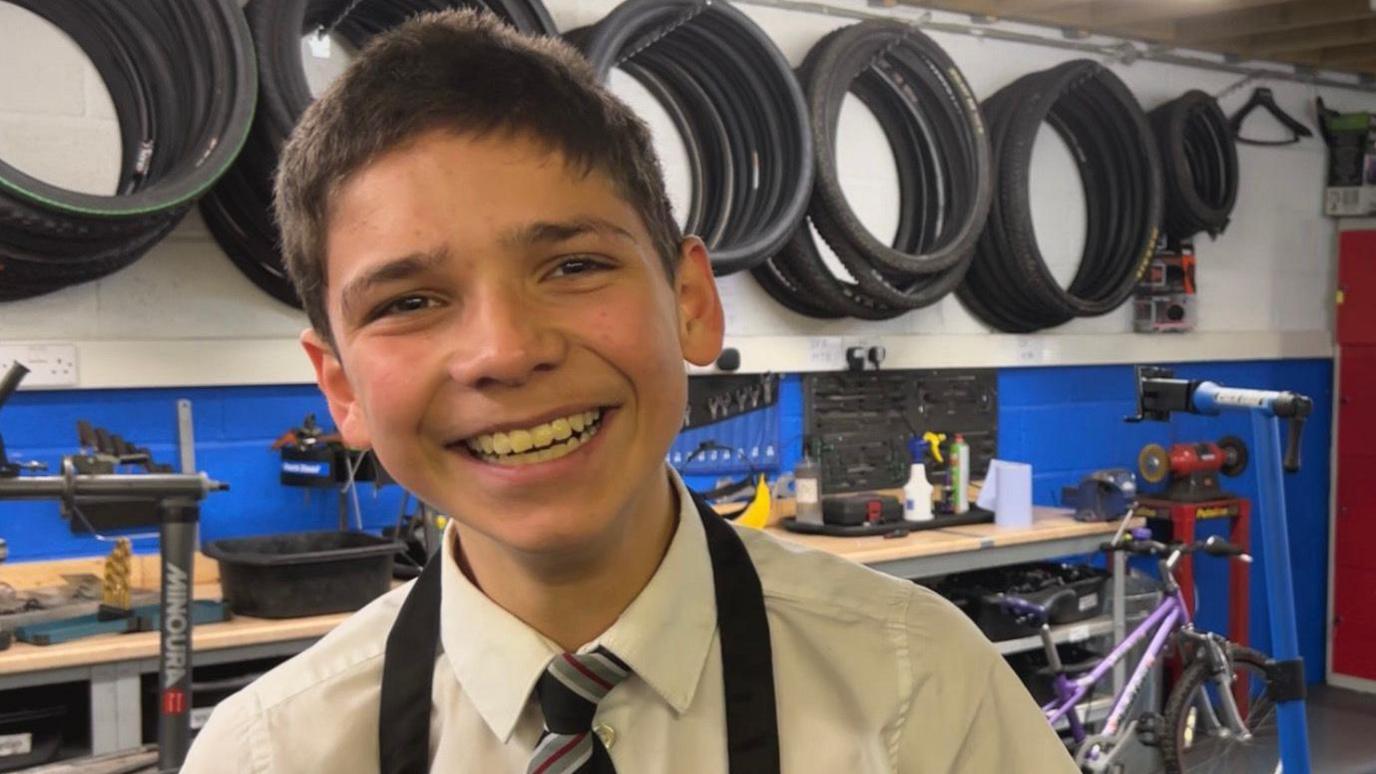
[1128,366,1314,774]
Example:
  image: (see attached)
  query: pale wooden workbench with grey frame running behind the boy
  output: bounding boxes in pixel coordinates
[0,508,1121,755]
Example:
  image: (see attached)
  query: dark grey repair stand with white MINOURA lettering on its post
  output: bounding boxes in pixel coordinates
[0,364,228,773]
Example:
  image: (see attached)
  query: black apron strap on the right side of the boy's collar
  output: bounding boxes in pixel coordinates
[694,493,779,774]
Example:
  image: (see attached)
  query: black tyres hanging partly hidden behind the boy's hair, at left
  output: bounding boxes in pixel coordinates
[201,0,557,308]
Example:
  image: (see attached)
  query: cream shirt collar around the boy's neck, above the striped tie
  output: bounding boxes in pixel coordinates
[440,468,717,744]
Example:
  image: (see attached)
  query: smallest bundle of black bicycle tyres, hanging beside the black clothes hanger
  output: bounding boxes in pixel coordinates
[1148,90,1237,240]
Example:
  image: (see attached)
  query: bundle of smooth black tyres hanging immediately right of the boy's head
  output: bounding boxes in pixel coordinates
[567,0,813,274]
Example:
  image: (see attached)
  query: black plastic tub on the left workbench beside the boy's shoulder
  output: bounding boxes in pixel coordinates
[204,532,402,618]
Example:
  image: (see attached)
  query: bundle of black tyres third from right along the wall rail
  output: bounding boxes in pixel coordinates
[755,21,992,320]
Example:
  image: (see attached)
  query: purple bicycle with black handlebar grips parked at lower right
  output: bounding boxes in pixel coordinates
[1002,530,1280,774]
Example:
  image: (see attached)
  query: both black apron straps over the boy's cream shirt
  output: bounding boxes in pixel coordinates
[378,494,779,774]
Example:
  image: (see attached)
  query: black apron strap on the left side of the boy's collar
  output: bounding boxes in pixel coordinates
[377,551,444,774]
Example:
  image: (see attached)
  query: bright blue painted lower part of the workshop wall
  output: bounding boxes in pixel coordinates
[0,359,1332,679]
